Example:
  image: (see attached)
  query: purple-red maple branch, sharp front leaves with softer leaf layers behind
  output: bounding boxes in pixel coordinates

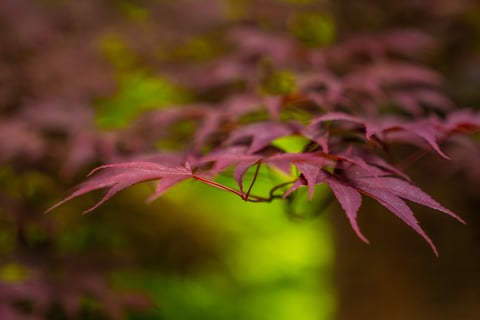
[46,28,480,254]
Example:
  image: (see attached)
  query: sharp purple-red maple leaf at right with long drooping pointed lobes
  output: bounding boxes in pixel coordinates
[272,151,465,255]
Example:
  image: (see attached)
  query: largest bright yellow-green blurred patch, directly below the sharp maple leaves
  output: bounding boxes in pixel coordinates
[115,178,335,320]
